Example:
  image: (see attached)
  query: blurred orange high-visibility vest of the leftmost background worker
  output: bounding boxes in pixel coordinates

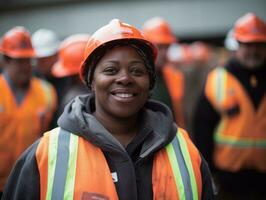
[0,75,56,191]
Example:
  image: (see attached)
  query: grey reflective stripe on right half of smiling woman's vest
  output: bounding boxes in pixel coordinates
[172,133,193,200]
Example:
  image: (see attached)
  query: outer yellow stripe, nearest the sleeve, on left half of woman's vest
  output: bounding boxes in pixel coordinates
[46,128,59,200]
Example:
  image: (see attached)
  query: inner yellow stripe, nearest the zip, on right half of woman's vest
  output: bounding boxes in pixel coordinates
[166,143,185,200]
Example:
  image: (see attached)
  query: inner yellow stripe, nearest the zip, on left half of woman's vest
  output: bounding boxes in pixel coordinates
[64,134,79,200]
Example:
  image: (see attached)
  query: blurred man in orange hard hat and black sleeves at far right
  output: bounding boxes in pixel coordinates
[194,13,266,199]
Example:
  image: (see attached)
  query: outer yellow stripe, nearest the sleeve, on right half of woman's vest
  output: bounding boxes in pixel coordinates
[177,132,199,200]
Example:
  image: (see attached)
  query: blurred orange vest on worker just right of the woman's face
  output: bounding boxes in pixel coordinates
[162,64,185,127]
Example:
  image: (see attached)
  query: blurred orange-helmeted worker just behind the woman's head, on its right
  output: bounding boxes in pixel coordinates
[143,17,185,127]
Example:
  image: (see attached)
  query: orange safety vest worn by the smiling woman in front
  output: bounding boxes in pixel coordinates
[36,128,202,200]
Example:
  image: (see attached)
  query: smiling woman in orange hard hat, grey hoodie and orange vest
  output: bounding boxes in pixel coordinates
[4,19,212,200]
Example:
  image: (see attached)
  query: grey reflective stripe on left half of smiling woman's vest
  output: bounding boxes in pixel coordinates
[51,128,70,200]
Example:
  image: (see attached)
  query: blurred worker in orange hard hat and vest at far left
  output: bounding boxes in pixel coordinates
[0,27,56,196]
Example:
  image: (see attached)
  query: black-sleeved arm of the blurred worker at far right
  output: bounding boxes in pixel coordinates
[193,89,220,169]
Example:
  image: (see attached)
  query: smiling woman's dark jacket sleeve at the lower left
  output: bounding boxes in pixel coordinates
[2,140,40,200]
